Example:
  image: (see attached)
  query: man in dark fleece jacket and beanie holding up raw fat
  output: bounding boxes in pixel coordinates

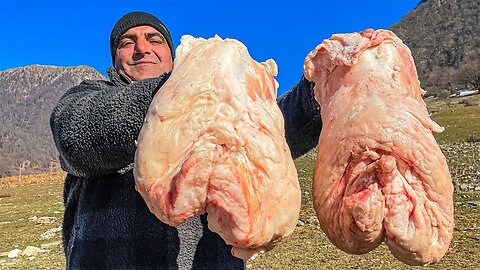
[50,12,321,270]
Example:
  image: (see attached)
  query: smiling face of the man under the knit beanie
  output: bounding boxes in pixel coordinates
[115,25,173,81]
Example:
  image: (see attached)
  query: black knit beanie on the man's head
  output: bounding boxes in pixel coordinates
[110,11,175,66]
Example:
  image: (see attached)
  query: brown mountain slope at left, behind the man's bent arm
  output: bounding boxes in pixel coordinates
[0,65,105,177]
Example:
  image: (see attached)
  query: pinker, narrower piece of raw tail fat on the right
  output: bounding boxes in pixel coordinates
[304,29,454,265]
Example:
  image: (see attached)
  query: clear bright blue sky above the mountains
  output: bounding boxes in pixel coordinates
[0,0,419,94]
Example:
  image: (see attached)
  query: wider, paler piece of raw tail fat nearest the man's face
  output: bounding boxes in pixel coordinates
[134,36,301,259]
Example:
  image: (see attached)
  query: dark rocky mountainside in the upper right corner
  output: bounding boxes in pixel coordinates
[390,0,480,97]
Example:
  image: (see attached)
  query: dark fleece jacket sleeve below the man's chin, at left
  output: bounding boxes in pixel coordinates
[50,74,168,178]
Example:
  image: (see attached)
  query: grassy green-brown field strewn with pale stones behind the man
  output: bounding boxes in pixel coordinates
[0,97,480,270]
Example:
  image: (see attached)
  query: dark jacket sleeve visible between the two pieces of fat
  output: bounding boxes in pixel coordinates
[277,76,322,158]
